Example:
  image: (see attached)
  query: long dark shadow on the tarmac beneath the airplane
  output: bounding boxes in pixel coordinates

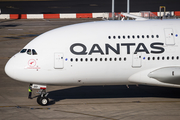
[48,85,180,104]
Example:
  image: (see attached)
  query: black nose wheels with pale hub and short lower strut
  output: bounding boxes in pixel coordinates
[37,89,49,106]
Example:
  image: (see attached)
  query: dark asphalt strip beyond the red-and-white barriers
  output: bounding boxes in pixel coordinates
[0,0,180,14]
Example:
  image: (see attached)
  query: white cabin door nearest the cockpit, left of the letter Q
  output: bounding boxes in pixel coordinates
[54,53,64,69]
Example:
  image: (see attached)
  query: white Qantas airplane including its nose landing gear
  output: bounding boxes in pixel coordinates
[5,17,180,105]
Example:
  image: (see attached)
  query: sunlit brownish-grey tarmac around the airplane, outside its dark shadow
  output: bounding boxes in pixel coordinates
[0,19,180,120]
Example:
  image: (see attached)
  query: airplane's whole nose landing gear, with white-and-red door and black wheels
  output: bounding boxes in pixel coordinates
[32,84,49,106]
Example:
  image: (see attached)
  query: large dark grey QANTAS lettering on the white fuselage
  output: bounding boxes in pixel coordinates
[70,42,165,55]
